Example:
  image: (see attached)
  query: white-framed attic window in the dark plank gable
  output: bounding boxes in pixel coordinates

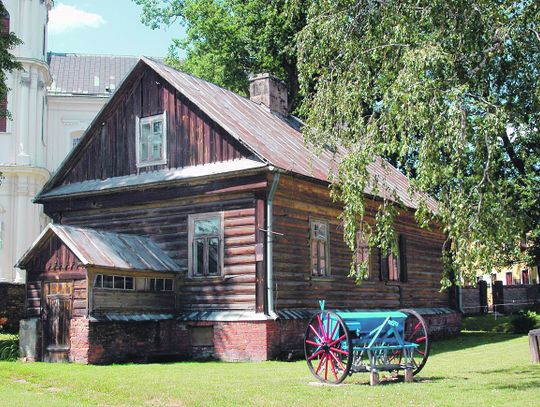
[136,112,167,167]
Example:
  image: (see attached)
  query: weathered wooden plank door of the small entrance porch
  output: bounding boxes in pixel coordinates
[43,281,73,362]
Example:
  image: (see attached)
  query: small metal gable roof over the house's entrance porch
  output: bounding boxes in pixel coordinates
[16,223,180,273]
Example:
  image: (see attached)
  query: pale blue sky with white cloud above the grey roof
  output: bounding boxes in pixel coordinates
[48,0,183,57]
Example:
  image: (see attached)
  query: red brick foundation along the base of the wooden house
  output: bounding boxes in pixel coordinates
[20,312,461,364]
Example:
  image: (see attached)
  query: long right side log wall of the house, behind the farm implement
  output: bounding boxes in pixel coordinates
[273,176,448,309]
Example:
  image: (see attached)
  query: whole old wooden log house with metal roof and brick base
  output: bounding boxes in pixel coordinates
[18,58,459,363]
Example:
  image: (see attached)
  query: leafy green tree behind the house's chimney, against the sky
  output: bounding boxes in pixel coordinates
[133,0,309,109]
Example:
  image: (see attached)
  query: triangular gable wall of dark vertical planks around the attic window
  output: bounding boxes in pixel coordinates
[57,68,250,184]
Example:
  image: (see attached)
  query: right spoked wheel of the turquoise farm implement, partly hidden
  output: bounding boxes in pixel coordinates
[389,309,431,375]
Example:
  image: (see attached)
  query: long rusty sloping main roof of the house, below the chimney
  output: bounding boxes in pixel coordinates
[142,57,435,212]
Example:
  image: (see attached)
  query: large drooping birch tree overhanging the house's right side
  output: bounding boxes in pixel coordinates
[297,0,540,285]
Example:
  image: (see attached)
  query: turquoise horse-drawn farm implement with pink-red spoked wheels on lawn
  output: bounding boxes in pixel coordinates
[304,301,430,384]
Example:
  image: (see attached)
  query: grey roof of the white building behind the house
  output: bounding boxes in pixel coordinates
[48,52,139,97]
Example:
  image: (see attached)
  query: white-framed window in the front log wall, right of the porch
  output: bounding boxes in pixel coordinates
[189,212,223,277]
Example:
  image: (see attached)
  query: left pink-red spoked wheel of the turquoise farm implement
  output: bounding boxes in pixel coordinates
[304,311,353,384]
